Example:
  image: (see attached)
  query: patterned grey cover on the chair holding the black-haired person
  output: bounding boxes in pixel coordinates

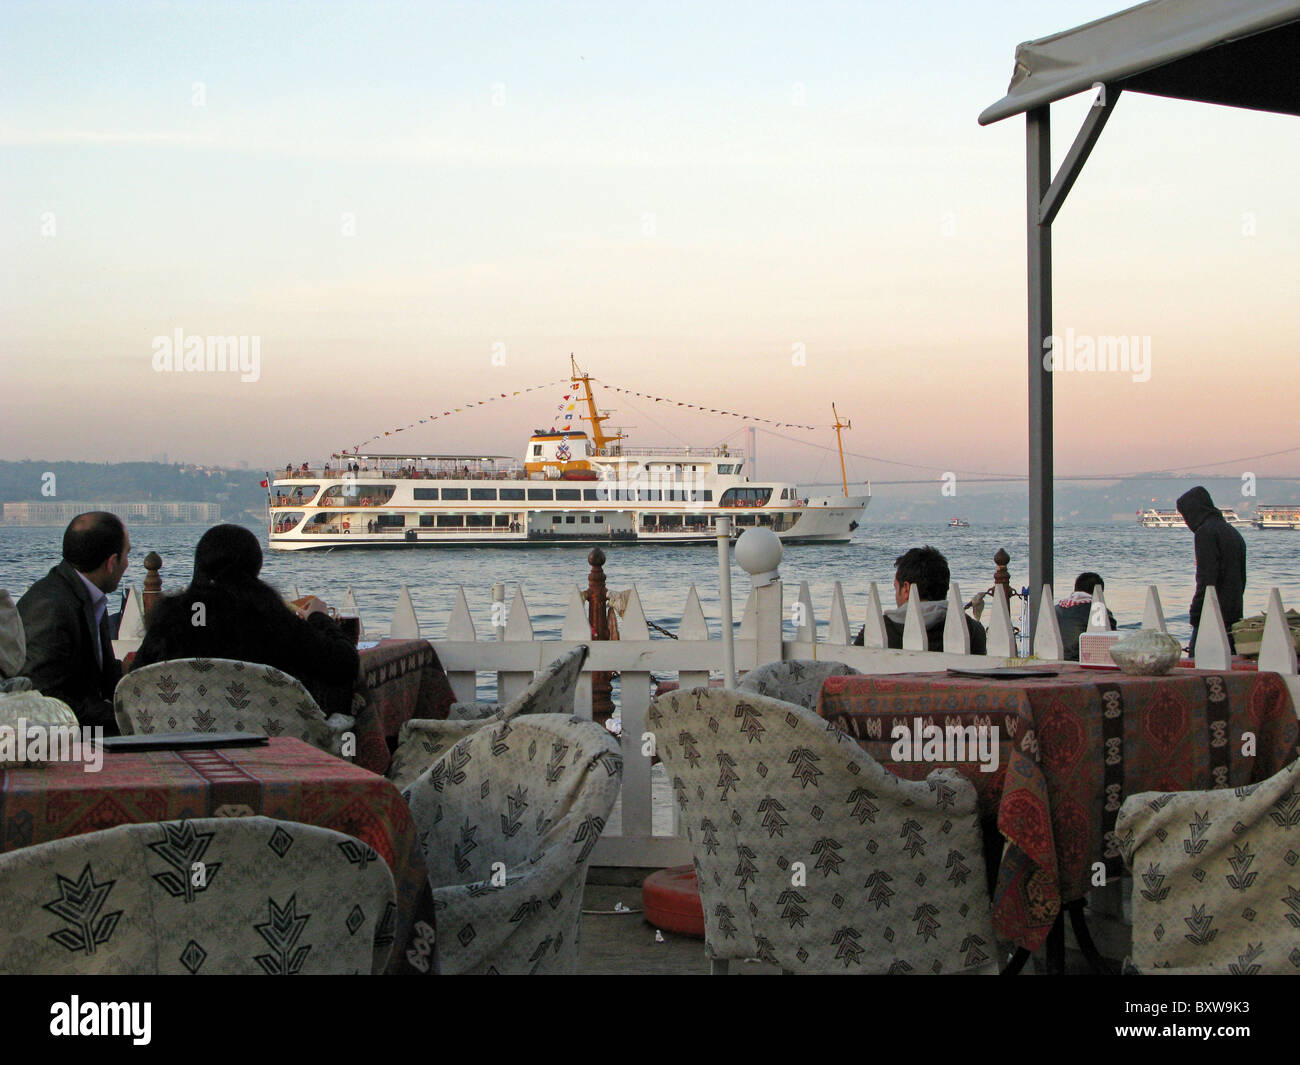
[113,658,356,756]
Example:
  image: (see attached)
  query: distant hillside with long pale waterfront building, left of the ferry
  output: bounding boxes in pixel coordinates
[0,460,267,519]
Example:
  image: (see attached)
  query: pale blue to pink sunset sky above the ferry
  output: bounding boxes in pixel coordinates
[0,0,1300,481]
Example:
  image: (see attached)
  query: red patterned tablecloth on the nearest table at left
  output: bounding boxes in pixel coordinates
[0,737,434,973]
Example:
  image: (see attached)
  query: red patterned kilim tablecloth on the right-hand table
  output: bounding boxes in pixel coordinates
[818,664,1300,951]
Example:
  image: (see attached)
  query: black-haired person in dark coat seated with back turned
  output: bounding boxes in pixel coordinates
[131,525,359,715]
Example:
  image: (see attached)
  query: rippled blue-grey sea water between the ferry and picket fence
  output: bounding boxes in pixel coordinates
[0,511,1300,644]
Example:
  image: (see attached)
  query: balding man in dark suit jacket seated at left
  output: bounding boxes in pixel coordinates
[18,511,131,736]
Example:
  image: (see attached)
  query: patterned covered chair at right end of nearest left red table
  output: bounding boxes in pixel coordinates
[403,714,623,974]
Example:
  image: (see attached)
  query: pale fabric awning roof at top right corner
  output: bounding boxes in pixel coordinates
[979,0,1300,125]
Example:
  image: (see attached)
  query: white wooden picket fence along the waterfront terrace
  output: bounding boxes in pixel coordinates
[116,566,1300,867]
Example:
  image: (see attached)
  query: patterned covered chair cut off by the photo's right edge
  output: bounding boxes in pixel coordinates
[1115,762,1300,975]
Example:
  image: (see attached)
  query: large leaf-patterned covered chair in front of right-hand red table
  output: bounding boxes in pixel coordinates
[647,688,997,974]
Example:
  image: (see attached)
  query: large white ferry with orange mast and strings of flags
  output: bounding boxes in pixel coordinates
[268,364,871,551]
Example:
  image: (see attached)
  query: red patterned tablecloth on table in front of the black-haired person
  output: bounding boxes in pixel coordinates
[355,640,456,774]
